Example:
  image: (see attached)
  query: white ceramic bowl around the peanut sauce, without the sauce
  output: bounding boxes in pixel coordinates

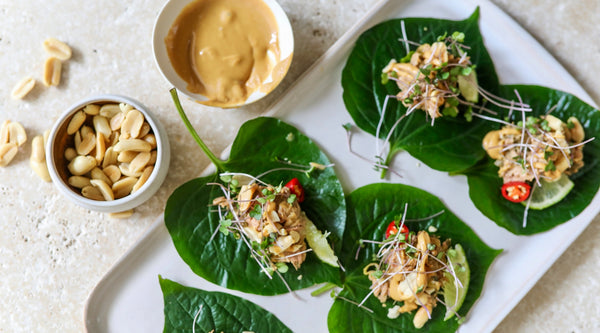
[152,0,294,107]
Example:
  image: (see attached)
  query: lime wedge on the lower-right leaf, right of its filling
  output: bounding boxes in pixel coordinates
[442,244,471,320]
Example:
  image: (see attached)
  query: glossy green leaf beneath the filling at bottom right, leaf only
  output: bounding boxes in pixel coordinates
[327,184,501,333]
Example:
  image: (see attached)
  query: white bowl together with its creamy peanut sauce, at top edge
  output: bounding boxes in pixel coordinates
[153,0,294,108]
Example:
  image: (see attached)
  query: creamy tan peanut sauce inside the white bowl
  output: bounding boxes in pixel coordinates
[165,0,291,107]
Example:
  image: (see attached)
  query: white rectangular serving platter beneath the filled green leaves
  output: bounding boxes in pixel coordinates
[84,0,600,332]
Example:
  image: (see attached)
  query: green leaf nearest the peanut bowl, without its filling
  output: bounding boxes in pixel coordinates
[164,117,346,295]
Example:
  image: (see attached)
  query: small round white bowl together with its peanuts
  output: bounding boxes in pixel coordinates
[46,95,170,213]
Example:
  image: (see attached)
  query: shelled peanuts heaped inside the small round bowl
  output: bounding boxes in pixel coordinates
[64,103,157,201]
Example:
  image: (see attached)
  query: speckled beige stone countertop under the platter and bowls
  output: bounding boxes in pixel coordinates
[0,0,600,332]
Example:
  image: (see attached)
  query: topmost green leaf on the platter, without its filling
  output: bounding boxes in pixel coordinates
[342,9,499,171]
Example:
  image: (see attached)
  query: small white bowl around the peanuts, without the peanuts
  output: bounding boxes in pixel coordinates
[46,95,171,212]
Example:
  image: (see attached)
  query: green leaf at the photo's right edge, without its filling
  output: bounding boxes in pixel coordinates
[465,85,600,235]
